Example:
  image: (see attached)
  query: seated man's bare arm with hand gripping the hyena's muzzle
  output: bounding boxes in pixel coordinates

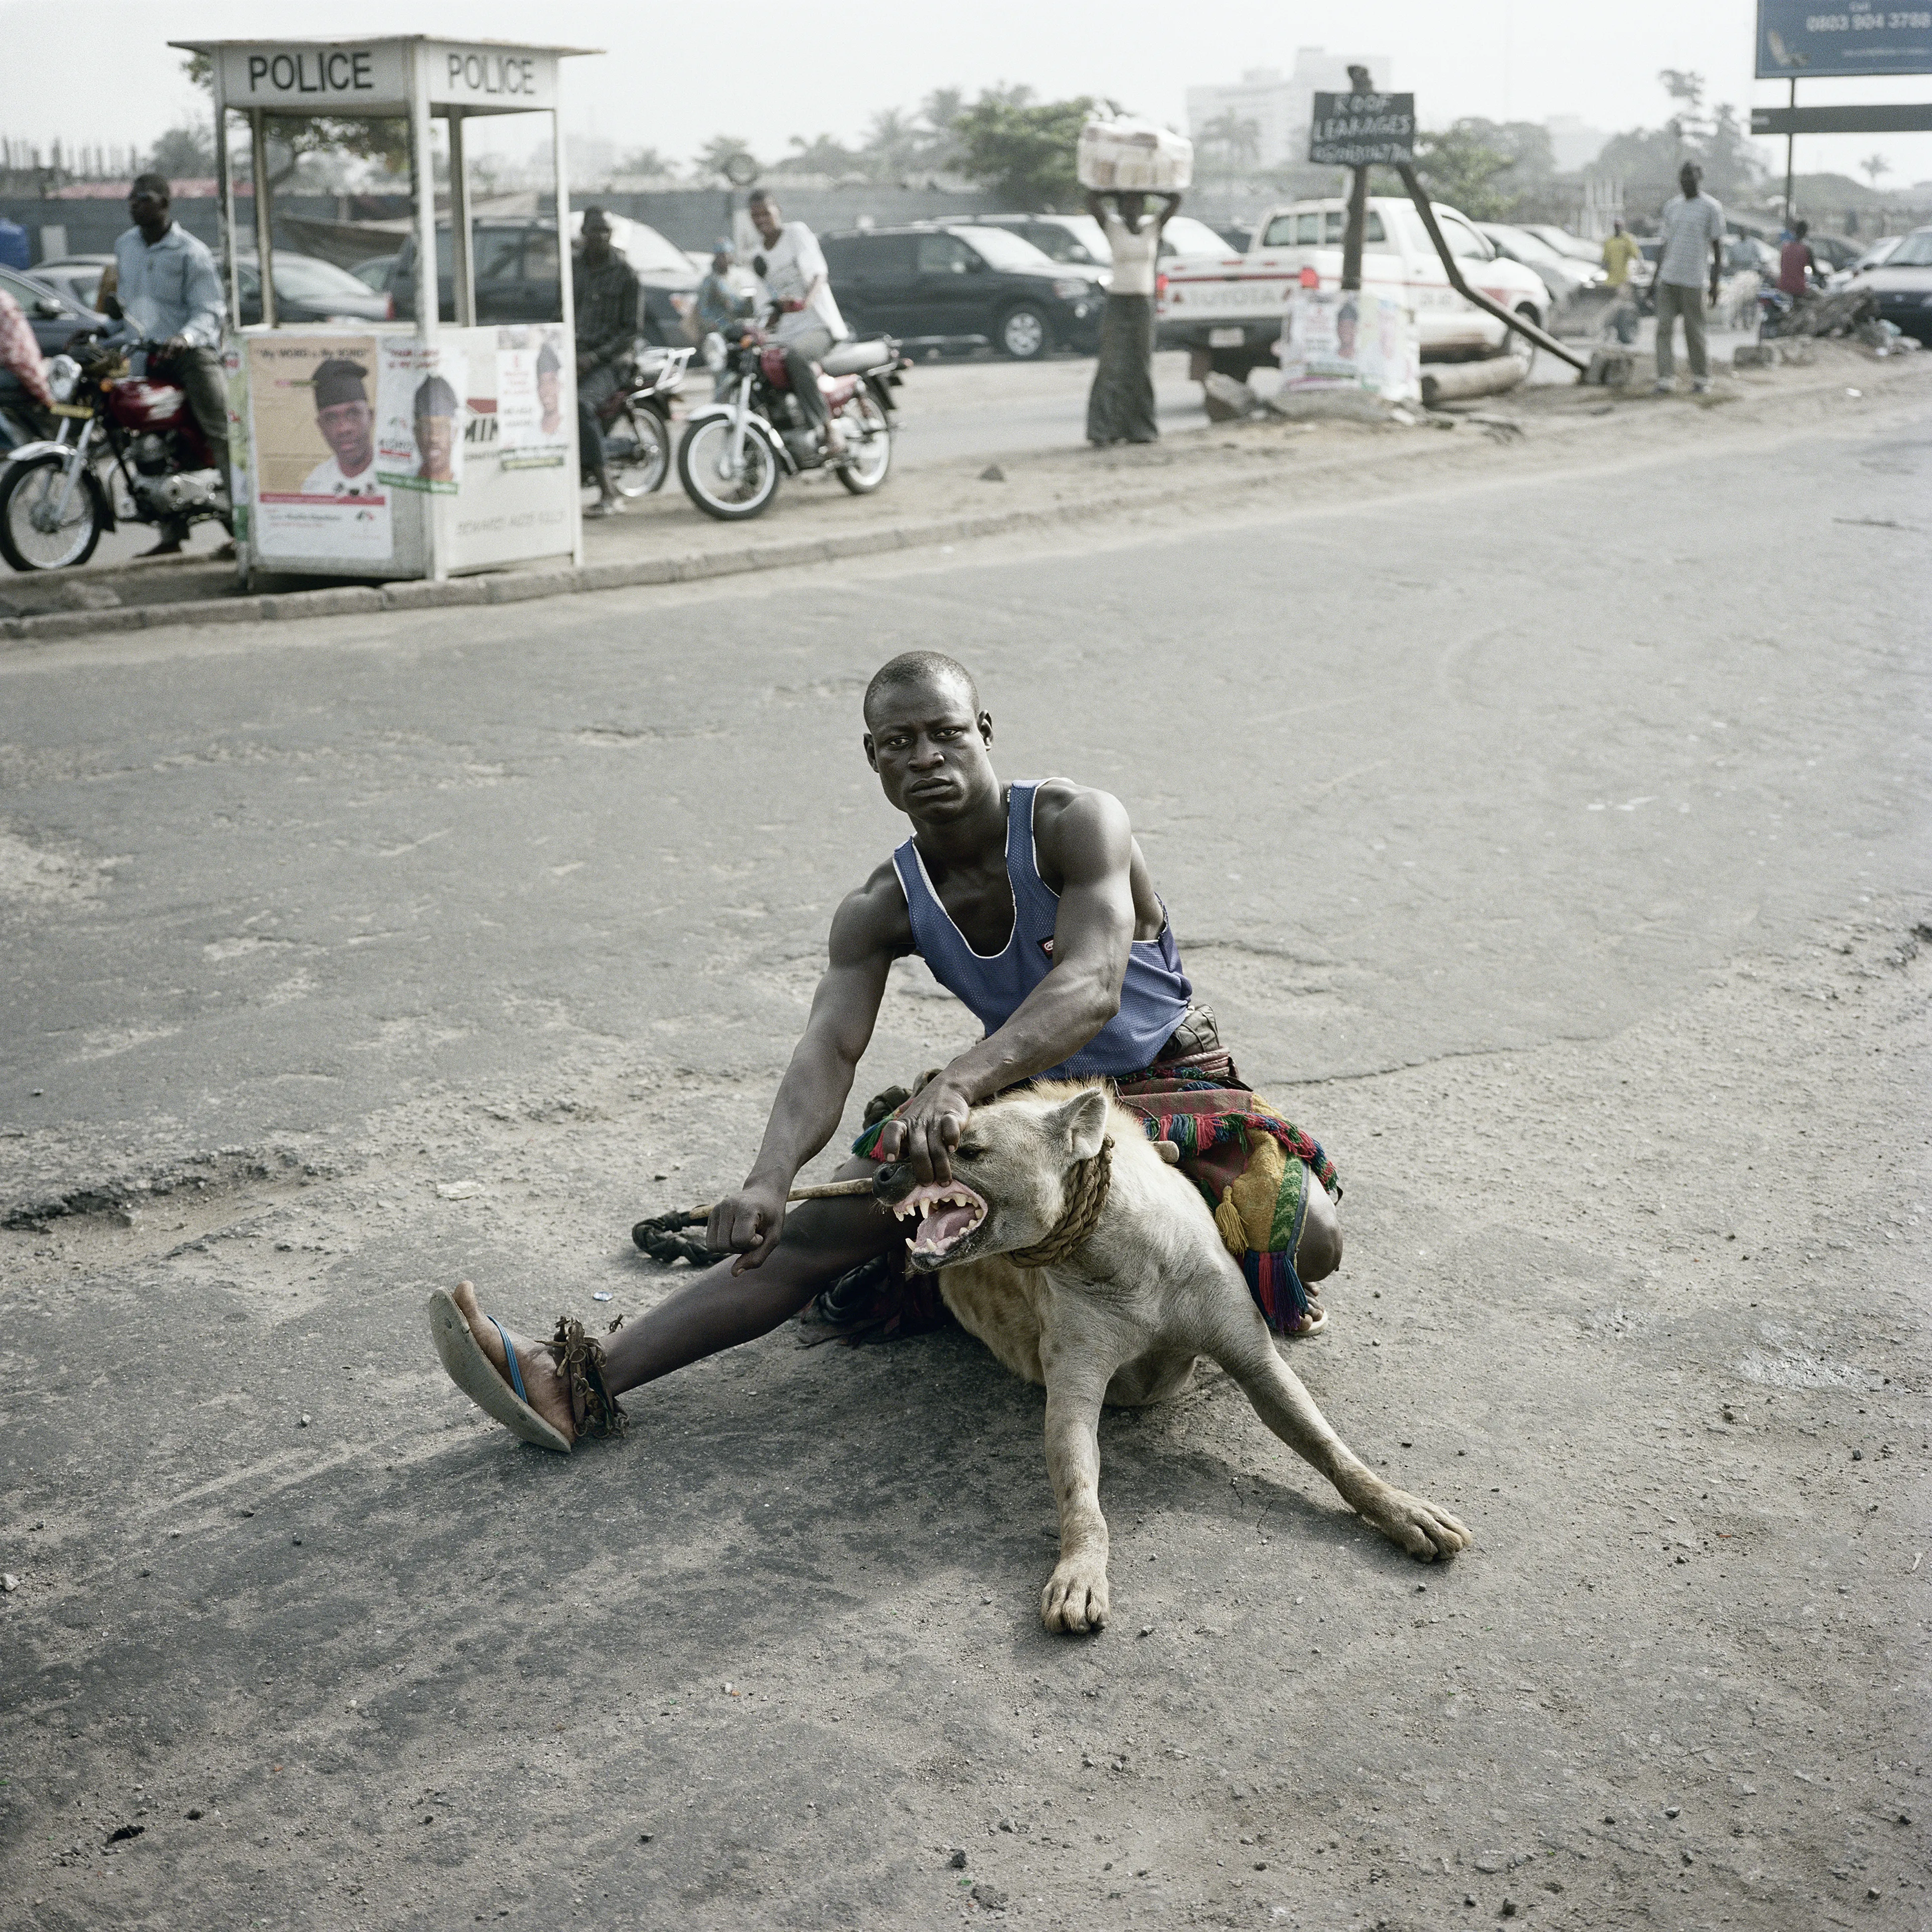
[883,792,1134,1180]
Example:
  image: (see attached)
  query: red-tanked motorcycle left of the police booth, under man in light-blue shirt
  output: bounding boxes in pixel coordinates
[0,334,234,570]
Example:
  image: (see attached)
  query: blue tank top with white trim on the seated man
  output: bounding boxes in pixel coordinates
[893,779,1194,1080]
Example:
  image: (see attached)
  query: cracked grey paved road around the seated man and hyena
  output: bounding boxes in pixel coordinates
[0,384,1932,1932]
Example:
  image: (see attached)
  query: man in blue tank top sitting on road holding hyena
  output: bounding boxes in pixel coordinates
[433,651,1341,1449]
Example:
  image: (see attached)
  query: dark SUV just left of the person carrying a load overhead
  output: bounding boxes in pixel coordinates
[819,222,1105,361]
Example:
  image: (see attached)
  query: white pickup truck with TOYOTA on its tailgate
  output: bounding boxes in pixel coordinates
[1155,195,1550,380]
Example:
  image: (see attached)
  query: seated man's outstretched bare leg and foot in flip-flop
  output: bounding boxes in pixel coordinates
[435,1161,904,1443]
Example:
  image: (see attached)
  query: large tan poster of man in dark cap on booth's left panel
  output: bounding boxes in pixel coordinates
[248,336,394,564]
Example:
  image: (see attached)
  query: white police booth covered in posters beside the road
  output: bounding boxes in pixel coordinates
[174,35,589,586]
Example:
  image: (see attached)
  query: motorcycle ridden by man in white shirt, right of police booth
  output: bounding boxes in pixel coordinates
[678,329,912,524]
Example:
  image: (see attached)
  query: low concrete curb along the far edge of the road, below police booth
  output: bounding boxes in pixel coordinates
[0,354,1932,643]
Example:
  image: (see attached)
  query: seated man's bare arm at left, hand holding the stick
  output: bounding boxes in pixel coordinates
[705,863,912,1273]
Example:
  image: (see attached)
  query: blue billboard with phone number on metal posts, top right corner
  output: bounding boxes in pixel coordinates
[1750,0,1932,222]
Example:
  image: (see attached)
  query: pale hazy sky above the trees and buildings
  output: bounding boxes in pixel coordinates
[0,0,1932,186]
